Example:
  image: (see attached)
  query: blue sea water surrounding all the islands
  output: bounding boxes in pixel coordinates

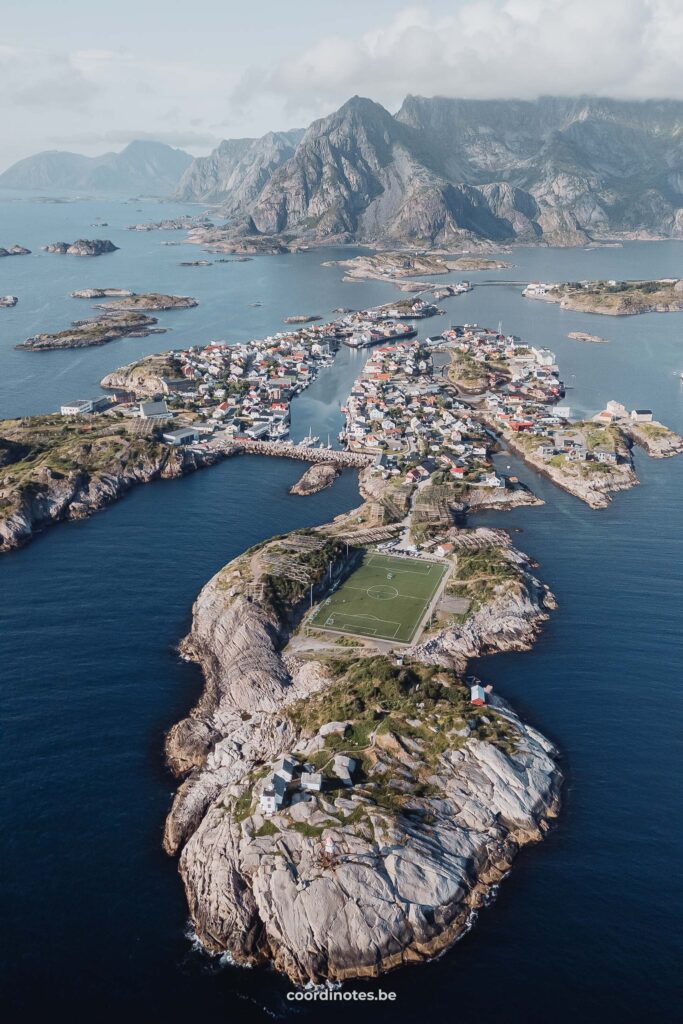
[0,193,683,1024]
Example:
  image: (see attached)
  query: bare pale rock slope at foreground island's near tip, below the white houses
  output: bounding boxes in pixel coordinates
[180,716,558,983]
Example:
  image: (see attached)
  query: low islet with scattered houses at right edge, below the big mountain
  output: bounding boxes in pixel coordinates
[522,278,683,313]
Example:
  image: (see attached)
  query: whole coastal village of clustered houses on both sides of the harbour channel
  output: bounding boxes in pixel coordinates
[54,297,683,507]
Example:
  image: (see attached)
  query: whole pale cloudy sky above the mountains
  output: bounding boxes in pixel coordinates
[0,0,683,169]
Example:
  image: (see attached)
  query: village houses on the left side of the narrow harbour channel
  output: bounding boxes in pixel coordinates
[60,299,439,446]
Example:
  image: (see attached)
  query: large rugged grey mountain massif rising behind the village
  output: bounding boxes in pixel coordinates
[176,96,683,246]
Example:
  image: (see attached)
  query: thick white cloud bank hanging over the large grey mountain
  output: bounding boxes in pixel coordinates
[232,0,683,113]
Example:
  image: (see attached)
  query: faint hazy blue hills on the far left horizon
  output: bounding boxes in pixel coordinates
[0,141,193,196]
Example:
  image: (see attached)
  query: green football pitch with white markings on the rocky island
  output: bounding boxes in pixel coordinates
[309,551,446,643]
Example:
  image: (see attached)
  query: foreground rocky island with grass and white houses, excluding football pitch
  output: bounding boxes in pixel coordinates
[164,468,561,984]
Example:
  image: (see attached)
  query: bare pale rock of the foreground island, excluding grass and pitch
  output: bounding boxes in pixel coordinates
[164,530,560,983]
